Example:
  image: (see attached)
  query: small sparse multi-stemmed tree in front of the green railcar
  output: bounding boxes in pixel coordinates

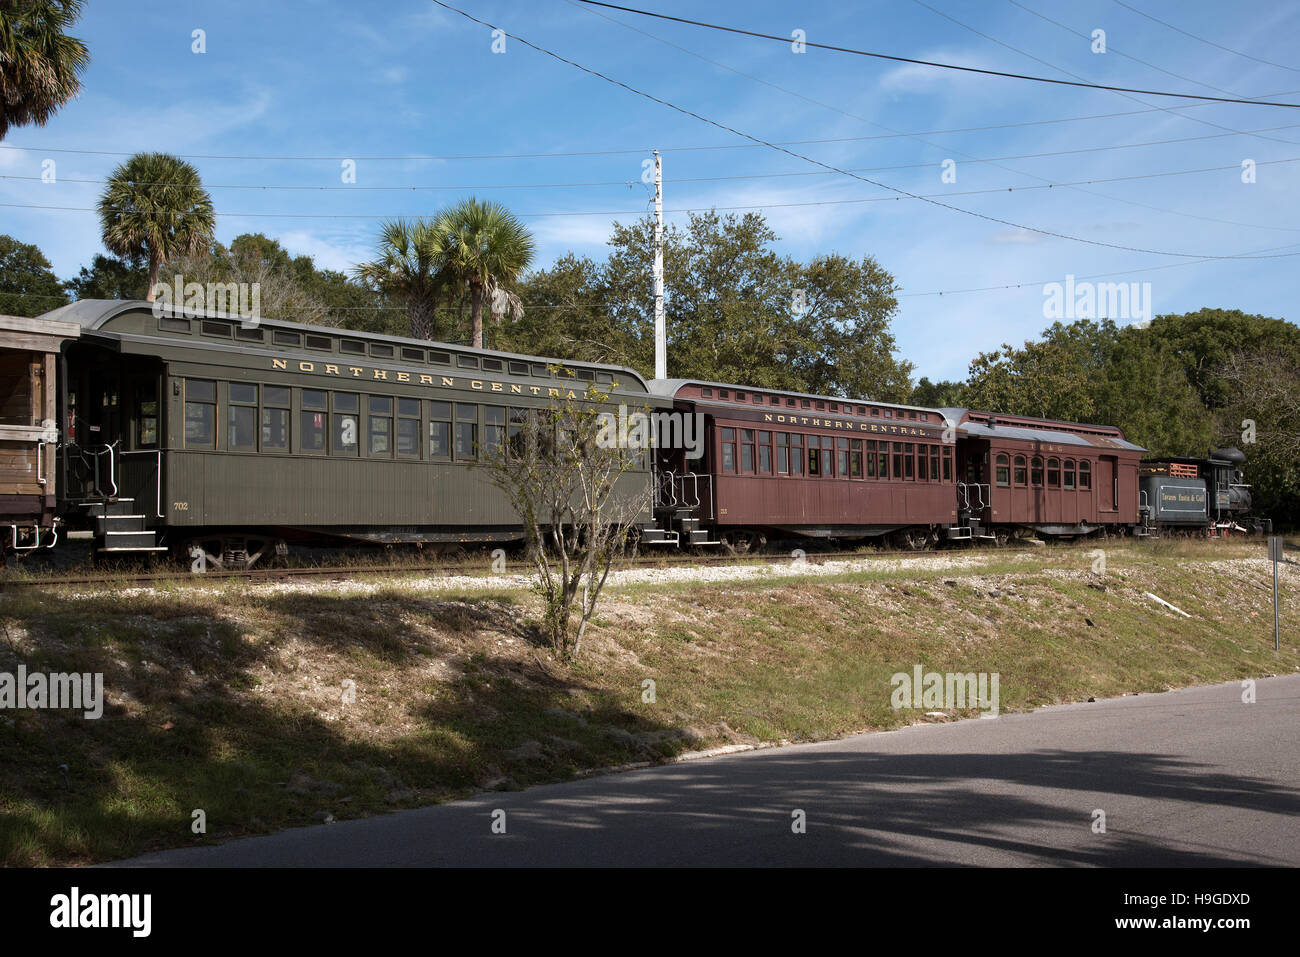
[484,371,649,661]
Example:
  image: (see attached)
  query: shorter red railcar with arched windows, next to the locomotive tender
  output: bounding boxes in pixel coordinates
[941,408,1145,541]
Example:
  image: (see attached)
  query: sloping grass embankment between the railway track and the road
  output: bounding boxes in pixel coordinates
[0,542,1300,865]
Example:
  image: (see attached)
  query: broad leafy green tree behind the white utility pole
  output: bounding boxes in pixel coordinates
[499,212,911,400]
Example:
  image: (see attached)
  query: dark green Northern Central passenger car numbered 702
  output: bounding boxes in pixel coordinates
[35,300,663,567]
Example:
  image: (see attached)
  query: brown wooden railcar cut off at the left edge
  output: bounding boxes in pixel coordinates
[0,316,81,558]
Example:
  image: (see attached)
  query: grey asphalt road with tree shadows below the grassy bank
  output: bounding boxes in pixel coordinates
[121,675,1300,867]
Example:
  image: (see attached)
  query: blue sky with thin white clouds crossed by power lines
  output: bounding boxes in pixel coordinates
[0,0,1300,378]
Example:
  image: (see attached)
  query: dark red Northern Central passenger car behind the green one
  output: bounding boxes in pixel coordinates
[651,380,957,549]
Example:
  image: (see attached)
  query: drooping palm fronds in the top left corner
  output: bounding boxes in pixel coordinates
[0,0,90,139]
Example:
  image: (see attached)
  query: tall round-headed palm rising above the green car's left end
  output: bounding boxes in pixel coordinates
[99,153,216,302]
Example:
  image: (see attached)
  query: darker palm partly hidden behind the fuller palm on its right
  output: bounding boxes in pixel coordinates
[352,220,445,339]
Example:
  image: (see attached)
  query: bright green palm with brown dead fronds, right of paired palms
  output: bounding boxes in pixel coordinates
[437,198,534,348]
